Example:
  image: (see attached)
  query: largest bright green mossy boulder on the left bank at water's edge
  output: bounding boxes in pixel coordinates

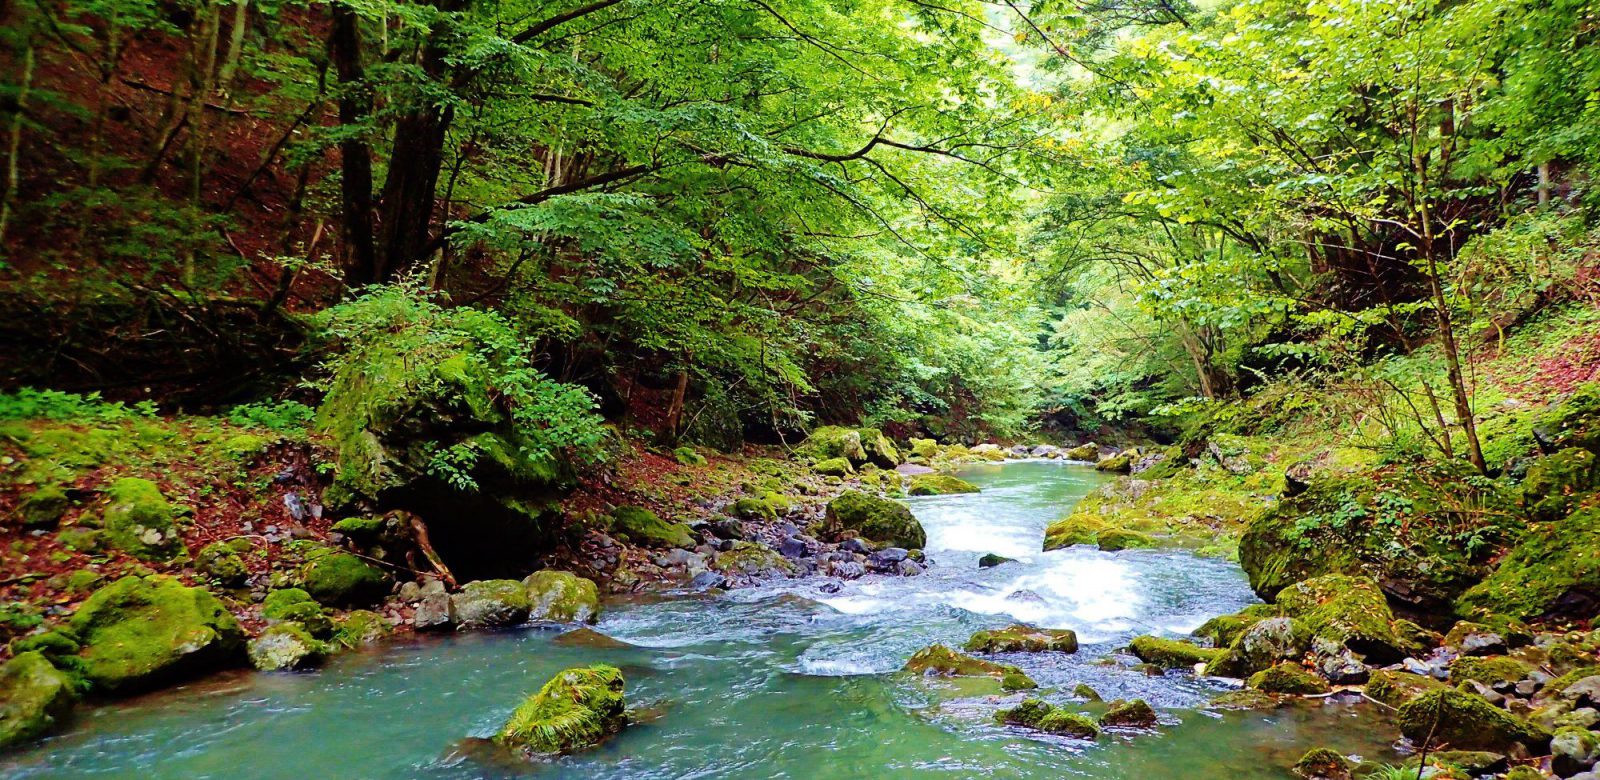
[67,575,245,692]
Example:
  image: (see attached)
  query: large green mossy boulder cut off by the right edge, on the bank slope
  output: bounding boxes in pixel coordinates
[1458,508,1600,620]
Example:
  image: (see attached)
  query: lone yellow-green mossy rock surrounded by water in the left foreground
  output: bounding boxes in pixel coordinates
[494,665,627,754]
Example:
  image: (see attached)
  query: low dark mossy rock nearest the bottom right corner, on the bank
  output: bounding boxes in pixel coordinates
[1398,687,1550,753]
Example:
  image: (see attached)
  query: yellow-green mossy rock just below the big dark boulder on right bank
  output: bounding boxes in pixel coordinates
[1277,574,1422,663]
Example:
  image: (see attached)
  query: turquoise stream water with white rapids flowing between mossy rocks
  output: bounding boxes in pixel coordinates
[0,462,1394,780]
